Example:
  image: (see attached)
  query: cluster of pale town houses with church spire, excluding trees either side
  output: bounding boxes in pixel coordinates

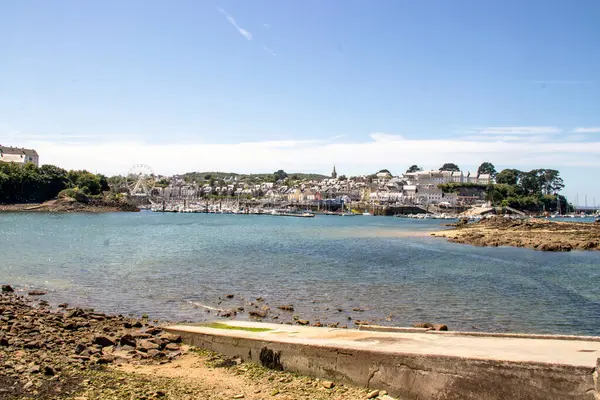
[153,167,492,206]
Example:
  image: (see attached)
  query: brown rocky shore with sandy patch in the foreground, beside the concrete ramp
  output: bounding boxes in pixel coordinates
[0,285,391,400]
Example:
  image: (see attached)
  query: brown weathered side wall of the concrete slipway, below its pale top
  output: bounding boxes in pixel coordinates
[171,331,600,400]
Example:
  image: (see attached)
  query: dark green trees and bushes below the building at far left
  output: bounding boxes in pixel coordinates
[0,162,110,204]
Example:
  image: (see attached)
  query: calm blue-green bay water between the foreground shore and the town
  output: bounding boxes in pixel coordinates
[0,212,600,335]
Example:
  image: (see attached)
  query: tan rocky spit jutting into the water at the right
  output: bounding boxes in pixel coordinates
[432,217,600,251]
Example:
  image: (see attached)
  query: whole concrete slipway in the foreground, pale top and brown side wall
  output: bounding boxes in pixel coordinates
[166,321,600,400]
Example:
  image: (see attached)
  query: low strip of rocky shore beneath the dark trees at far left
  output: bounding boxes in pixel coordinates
[0,198,139,213]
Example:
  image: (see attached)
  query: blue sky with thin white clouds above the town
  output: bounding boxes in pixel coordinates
[0,0,600,205]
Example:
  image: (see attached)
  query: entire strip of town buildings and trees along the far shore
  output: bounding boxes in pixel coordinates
[0,146,584,215]
